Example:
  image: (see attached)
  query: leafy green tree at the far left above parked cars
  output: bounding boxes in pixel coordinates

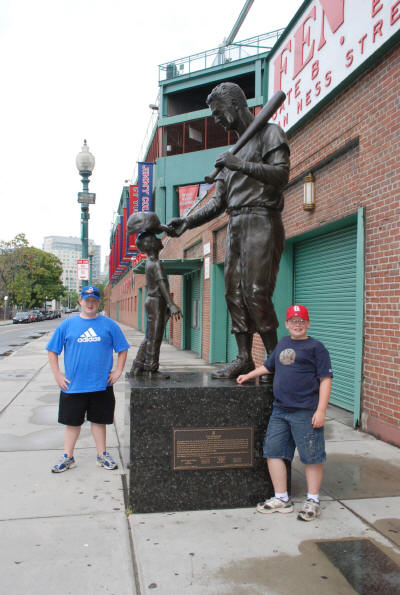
[0,234,65,309]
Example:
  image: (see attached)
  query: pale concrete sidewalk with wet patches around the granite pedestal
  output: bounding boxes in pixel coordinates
[0,325,400,595]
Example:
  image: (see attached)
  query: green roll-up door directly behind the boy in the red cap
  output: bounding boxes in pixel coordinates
[294,225,357,411]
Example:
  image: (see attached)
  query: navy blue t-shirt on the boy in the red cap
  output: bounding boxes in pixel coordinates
[264,337,333,410]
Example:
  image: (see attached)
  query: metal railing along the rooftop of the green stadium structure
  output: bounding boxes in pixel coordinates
[158,29,285,81]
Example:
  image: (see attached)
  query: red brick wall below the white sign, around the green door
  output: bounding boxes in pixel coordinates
[284,48,400,445]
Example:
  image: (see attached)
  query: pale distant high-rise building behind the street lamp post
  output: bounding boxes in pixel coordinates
[43,236,101,291]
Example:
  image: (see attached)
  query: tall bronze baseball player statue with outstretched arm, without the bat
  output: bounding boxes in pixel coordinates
[168,83,290,378]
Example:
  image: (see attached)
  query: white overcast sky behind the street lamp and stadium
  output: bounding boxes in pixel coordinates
[0,0,302,264]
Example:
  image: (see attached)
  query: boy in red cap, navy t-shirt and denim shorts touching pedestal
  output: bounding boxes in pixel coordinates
[237,304,332,521]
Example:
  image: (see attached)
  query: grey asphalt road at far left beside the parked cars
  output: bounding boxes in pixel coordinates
[0,316,65,359]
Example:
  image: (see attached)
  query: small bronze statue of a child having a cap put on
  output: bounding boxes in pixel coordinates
[128,212,182,376]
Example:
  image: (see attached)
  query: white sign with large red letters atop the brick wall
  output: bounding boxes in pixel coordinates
[268,0,400,130]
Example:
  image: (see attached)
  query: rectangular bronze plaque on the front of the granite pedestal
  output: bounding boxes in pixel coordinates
[173,428,254,471]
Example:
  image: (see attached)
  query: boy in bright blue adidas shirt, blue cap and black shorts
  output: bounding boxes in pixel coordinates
[46,286,129,473]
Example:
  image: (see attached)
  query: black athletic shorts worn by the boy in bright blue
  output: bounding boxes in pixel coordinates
[58,386,115,426]
